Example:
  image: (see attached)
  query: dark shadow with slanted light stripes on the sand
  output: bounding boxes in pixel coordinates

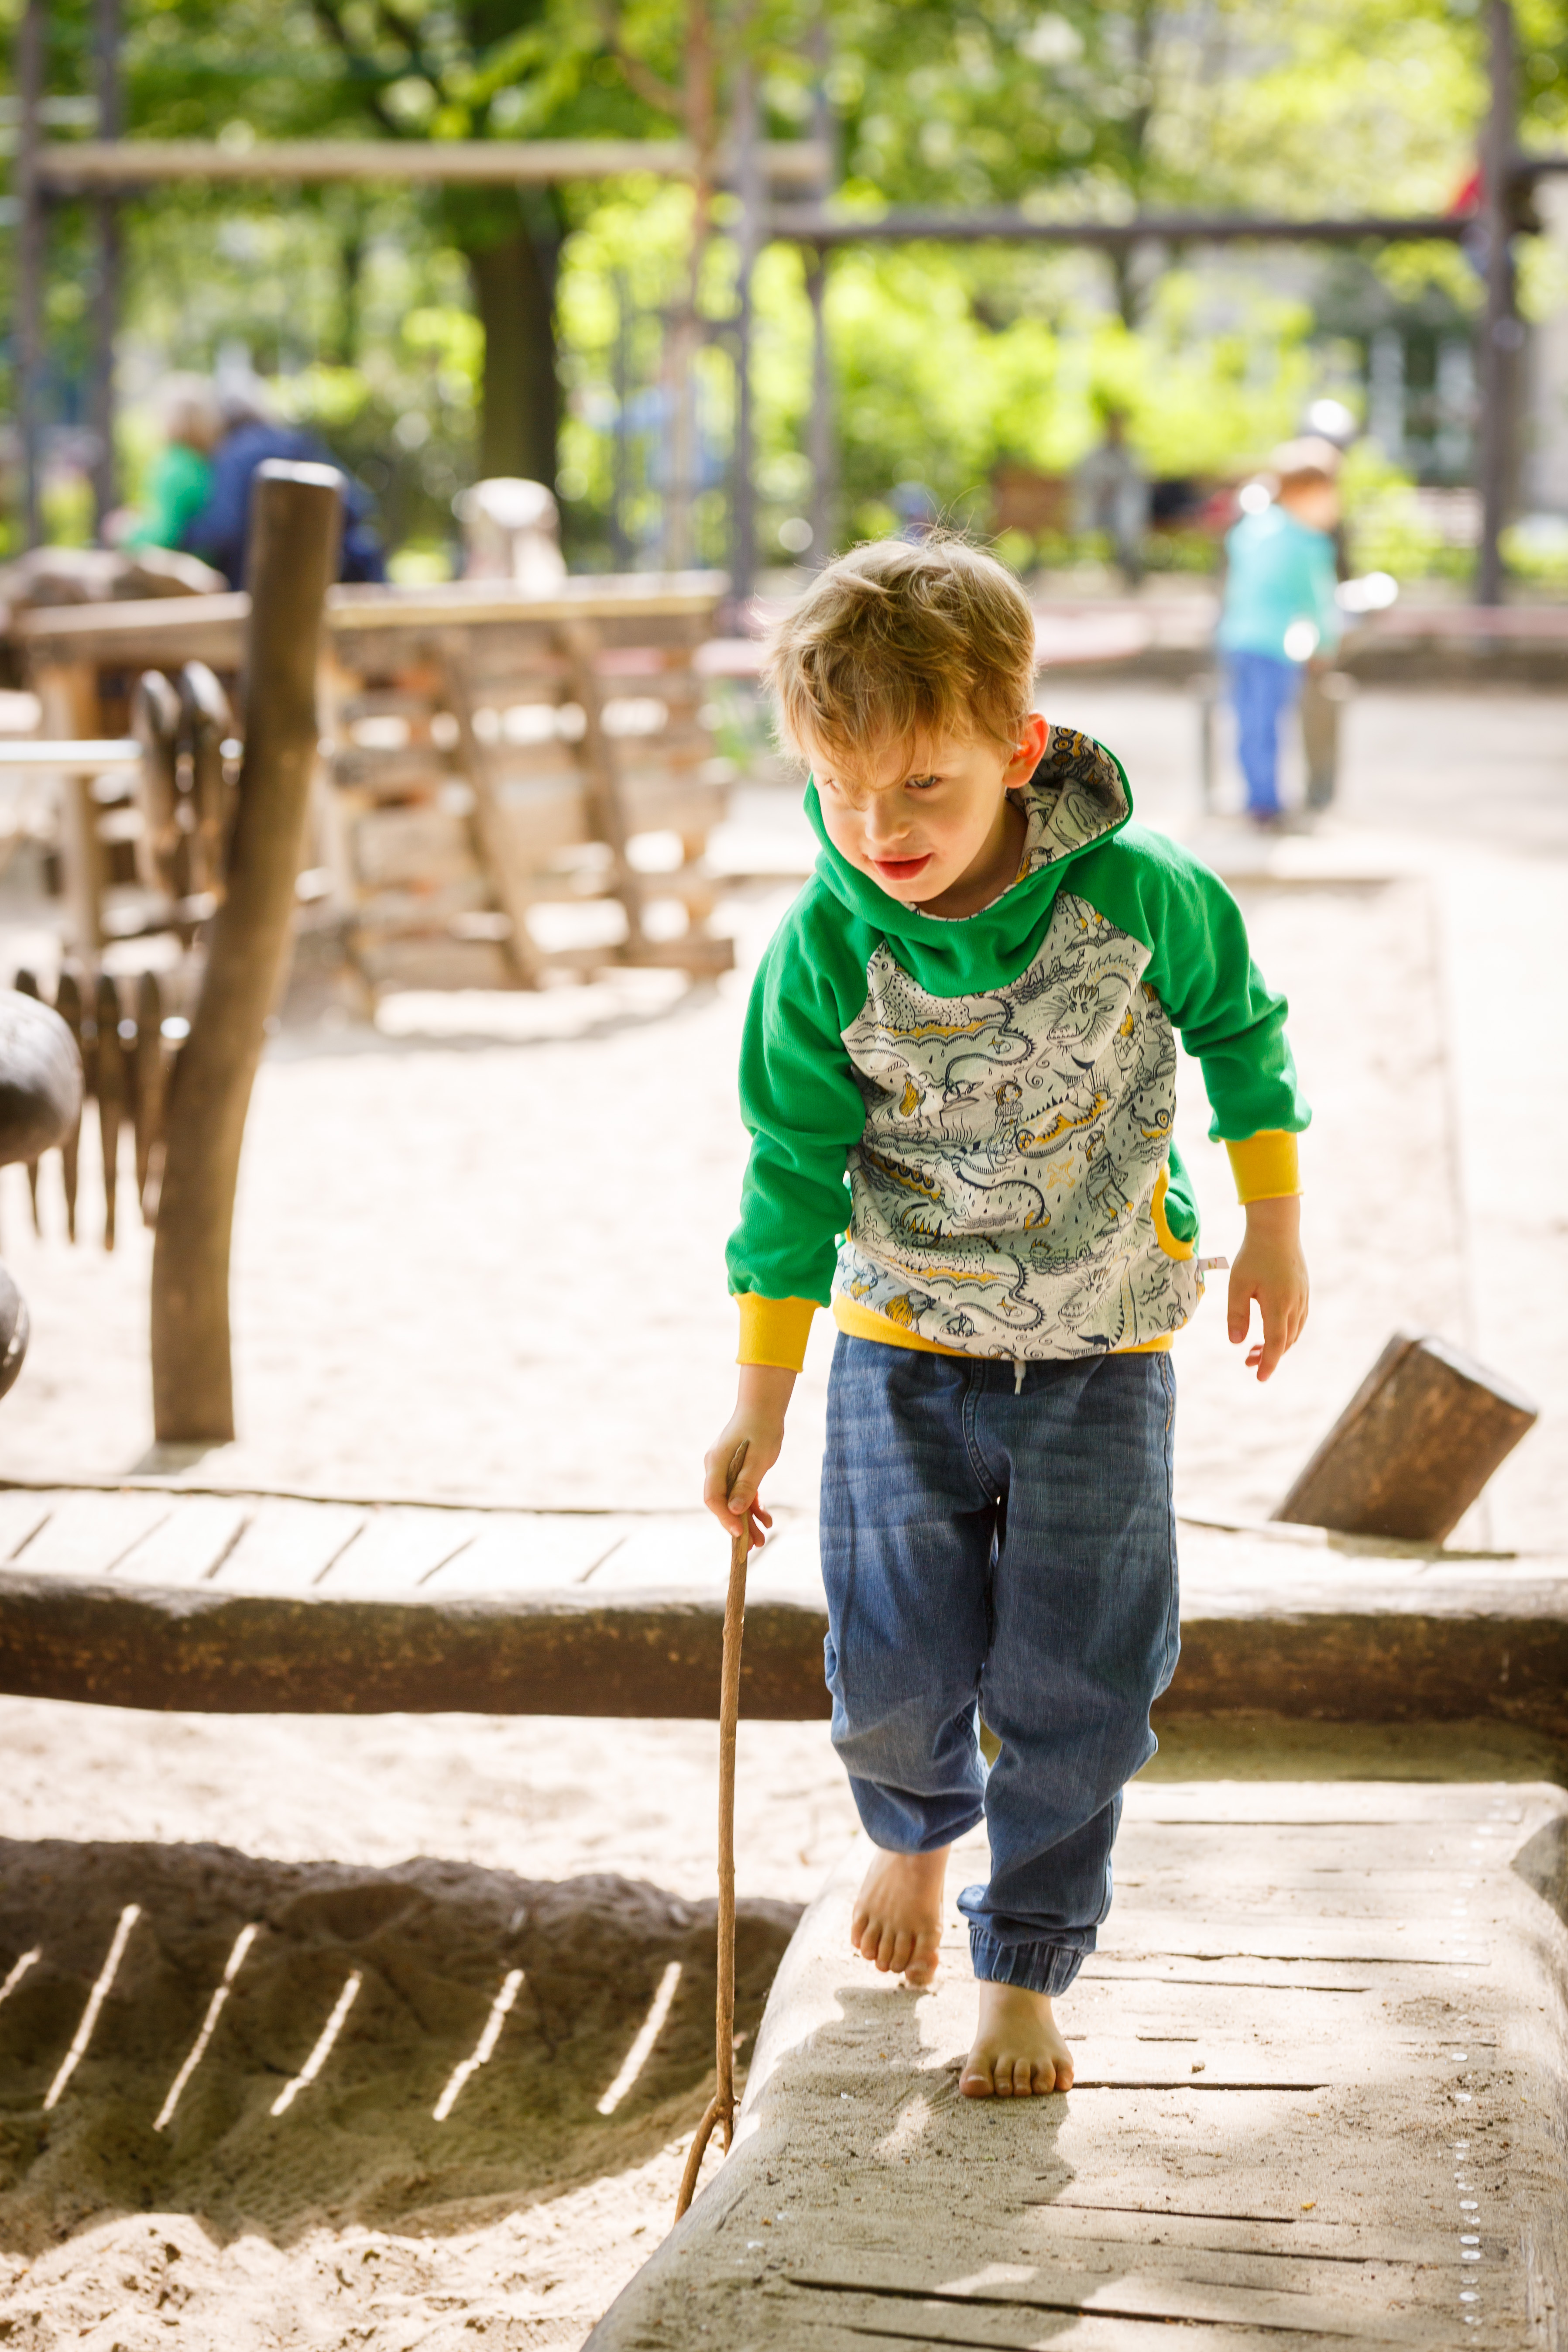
[0,1842,797,2253]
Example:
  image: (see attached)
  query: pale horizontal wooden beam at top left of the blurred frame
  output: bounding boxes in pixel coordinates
[35,139,827,195]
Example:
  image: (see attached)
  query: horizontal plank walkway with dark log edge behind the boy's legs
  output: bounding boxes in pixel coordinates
[0,1484,1568,1752]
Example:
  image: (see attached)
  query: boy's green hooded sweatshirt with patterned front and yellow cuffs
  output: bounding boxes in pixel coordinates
[729,727,1309,1364]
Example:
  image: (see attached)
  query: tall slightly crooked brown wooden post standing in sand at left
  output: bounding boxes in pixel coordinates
[153,459,343,1444]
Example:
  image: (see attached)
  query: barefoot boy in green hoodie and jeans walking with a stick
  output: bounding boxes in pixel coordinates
[705,539,1307,2098]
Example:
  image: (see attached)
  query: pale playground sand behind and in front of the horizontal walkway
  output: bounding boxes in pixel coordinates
[0,689,1568,2352]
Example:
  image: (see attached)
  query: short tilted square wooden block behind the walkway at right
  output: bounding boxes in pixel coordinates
[1274,1331,1537,1543]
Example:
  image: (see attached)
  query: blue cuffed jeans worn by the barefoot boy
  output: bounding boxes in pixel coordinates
[823,1331,1178,1992]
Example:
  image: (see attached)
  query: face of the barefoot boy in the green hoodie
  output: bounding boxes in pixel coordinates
[811,713,1049,913]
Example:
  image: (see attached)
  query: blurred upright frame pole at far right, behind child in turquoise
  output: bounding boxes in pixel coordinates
[1476,0,1523,604]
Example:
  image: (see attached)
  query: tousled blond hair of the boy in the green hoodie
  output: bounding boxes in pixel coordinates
[764,532,1034,757]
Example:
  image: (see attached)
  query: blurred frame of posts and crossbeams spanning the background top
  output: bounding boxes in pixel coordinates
[17,0,1568,607]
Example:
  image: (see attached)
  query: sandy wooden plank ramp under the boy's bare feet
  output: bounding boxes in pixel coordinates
[590,1783,1568,2352]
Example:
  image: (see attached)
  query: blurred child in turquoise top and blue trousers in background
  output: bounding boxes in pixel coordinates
[1220,437,1340,826]
